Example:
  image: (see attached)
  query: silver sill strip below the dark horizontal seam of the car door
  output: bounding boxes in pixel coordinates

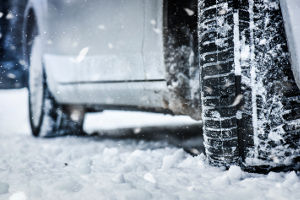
[55,81,168,111]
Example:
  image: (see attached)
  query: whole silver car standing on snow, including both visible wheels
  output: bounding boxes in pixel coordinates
[23,0,300,169]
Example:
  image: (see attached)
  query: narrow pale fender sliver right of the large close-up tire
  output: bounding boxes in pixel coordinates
[280,0,300,88]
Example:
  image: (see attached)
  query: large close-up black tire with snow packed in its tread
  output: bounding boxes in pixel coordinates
[198,0,300,168]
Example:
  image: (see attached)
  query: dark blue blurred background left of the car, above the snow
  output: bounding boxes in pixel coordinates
[0,0,28,89]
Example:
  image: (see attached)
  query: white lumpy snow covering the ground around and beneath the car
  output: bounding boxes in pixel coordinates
[0,90,300,200]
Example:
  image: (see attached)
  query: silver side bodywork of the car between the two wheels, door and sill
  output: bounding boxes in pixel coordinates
[28,0,170,112]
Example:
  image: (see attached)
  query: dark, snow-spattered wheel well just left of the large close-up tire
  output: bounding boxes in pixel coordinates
[163,0,201,119]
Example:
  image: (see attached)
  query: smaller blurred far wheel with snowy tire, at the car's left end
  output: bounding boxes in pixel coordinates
[28,36,84,137]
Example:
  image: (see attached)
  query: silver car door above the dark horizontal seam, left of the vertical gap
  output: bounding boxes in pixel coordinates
[45,0,145,83]
